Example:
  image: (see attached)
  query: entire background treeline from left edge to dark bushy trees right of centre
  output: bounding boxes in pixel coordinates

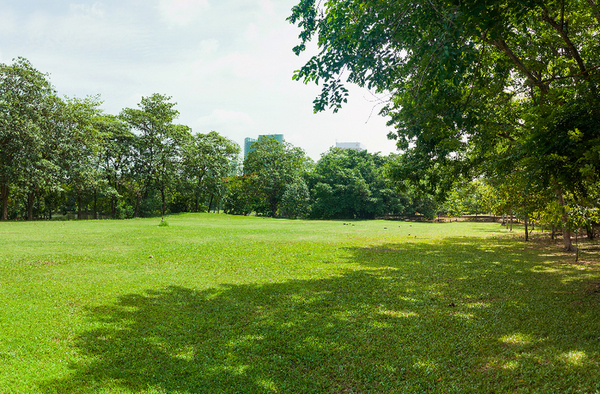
[0,58,436,220]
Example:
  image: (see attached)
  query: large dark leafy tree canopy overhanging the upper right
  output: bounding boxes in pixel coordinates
[289,0,600,249]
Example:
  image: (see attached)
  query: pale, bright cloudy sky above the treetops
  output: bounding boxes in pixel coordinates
[0,0,396,160]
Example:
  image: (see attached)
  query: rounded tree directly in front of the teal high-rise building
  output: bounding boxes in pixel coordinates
[244,137,309,217]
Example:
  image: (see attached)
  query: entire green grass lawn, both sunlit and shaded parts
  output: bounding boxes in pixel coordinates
[0,214,600,394]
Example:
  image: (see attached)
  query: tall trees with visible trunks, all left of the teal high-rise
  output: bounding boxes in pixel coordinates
[0,58,240,220]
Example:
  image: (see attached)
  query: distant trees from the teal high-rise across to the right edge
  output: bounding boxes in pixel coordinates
[238,138,600,243]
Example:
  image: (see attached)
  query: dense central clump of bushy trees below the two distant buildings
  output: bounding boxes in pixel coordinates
[224,138,437,219]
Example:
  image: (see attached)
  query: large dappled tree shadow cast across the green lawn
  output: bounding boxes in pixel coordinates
[41,238,600,393]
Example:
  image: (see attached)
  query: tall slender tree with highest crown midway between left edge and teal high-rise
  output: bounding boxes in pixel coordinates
[121,94,191,216]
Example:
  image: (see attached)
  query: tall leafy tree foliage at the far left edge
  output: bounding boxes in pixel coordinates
[0,58,101,220]
